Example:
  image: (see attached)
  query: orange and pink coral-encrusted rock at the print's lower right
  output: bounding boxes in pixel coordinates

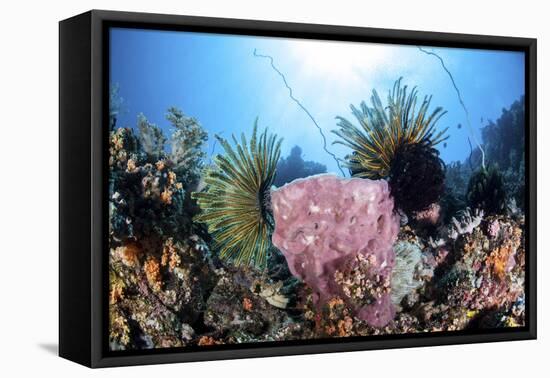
[437,214,525,326]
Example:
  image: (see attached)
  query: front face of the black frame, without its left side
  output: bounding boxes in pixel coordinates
[82,10,537,367]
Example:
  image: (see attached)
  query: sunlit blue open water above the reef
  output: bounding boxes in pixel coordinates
[110,28,525,172]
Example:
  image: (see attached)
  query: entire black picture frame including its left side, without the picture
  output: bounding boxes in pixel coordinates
[59,10,537,367]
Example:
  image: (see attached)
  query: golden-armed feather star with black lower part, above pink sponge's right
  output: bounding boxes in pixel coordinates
[333,79,448,215]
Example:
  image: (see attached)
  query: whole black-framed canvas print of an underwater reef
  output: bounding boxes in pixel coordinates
[59,11,536,367]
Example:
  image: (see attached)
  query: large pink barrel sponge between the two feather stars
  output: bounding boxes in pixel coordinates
[271,175,399,327]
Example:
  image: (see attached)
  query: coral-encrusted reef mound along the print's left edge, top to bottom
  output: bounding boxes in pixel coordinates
[109,109,215,349]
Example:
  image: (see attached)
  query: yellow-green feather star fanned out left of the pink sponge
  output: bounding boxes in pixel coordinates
[193,120,282,269]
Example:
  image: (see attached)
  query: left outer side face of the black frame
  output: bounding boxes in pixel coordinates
[59,12,93,366]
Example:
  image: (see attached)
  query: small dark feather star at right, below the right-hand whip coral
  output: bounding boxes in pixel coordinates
[466,166,507,215]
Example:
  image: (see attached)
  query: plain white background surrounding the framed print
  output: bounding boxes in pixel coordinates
[0,0,550,378]
